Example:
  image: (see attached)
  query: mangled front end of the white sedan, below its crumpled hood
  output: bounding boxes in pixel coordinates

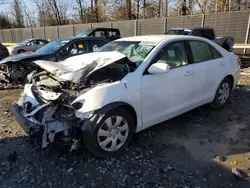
[12,79,83,150]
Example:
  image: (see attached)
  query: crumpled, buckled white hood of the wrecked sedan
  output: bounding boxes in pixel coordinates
[34,51,126,83]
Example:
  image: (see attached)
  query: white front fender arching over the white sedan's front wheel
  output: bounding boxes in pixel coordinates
[73,81,141,129]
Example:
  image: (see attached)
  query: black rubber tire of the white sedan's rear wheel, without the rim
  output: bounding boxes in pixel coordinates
[211,78,233,108]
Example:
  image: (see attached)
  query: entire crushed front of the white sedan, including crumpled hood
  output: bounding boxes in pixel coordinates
[12,52,134,150]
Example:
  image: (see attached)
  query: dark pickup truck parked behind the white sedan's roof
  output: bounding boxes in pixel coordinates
[165,27,234,52]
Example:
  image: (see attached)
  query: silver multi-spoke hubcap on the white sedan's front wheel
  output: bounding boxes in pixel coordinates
[97,116,129,151]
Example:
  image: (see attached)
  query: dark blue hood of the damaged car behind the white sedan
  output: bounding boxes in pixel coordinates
[0,52,46,64]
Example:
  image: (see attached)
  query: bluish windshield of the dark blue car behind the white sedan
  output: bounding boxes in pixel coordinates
[36,40,69,54]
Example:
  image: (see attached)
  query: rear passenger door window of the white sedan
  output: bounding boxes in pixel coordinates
[189,41,213,63]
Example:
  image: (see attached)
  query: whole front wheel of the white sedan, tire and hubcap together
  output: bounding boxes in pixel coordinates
[83,108,134,157]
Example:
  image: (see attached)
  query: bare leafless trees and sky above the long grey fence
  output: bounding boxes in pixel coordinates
[0,0,250,28]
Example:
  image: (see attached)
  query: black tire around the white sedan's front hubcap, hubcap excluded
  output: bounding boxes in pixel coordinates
[83,108,134,158]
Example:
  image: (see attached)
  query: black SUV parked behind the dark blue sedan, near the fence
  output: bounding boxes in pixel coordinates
[76,28,121,40]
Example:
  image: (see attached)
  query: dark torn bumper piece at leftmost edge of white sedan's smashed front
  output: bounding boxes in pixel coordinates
[11,102,42,136]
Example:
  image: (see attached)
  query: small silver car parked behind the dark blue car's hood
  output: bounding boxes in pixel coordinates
[7,39,49,55]
